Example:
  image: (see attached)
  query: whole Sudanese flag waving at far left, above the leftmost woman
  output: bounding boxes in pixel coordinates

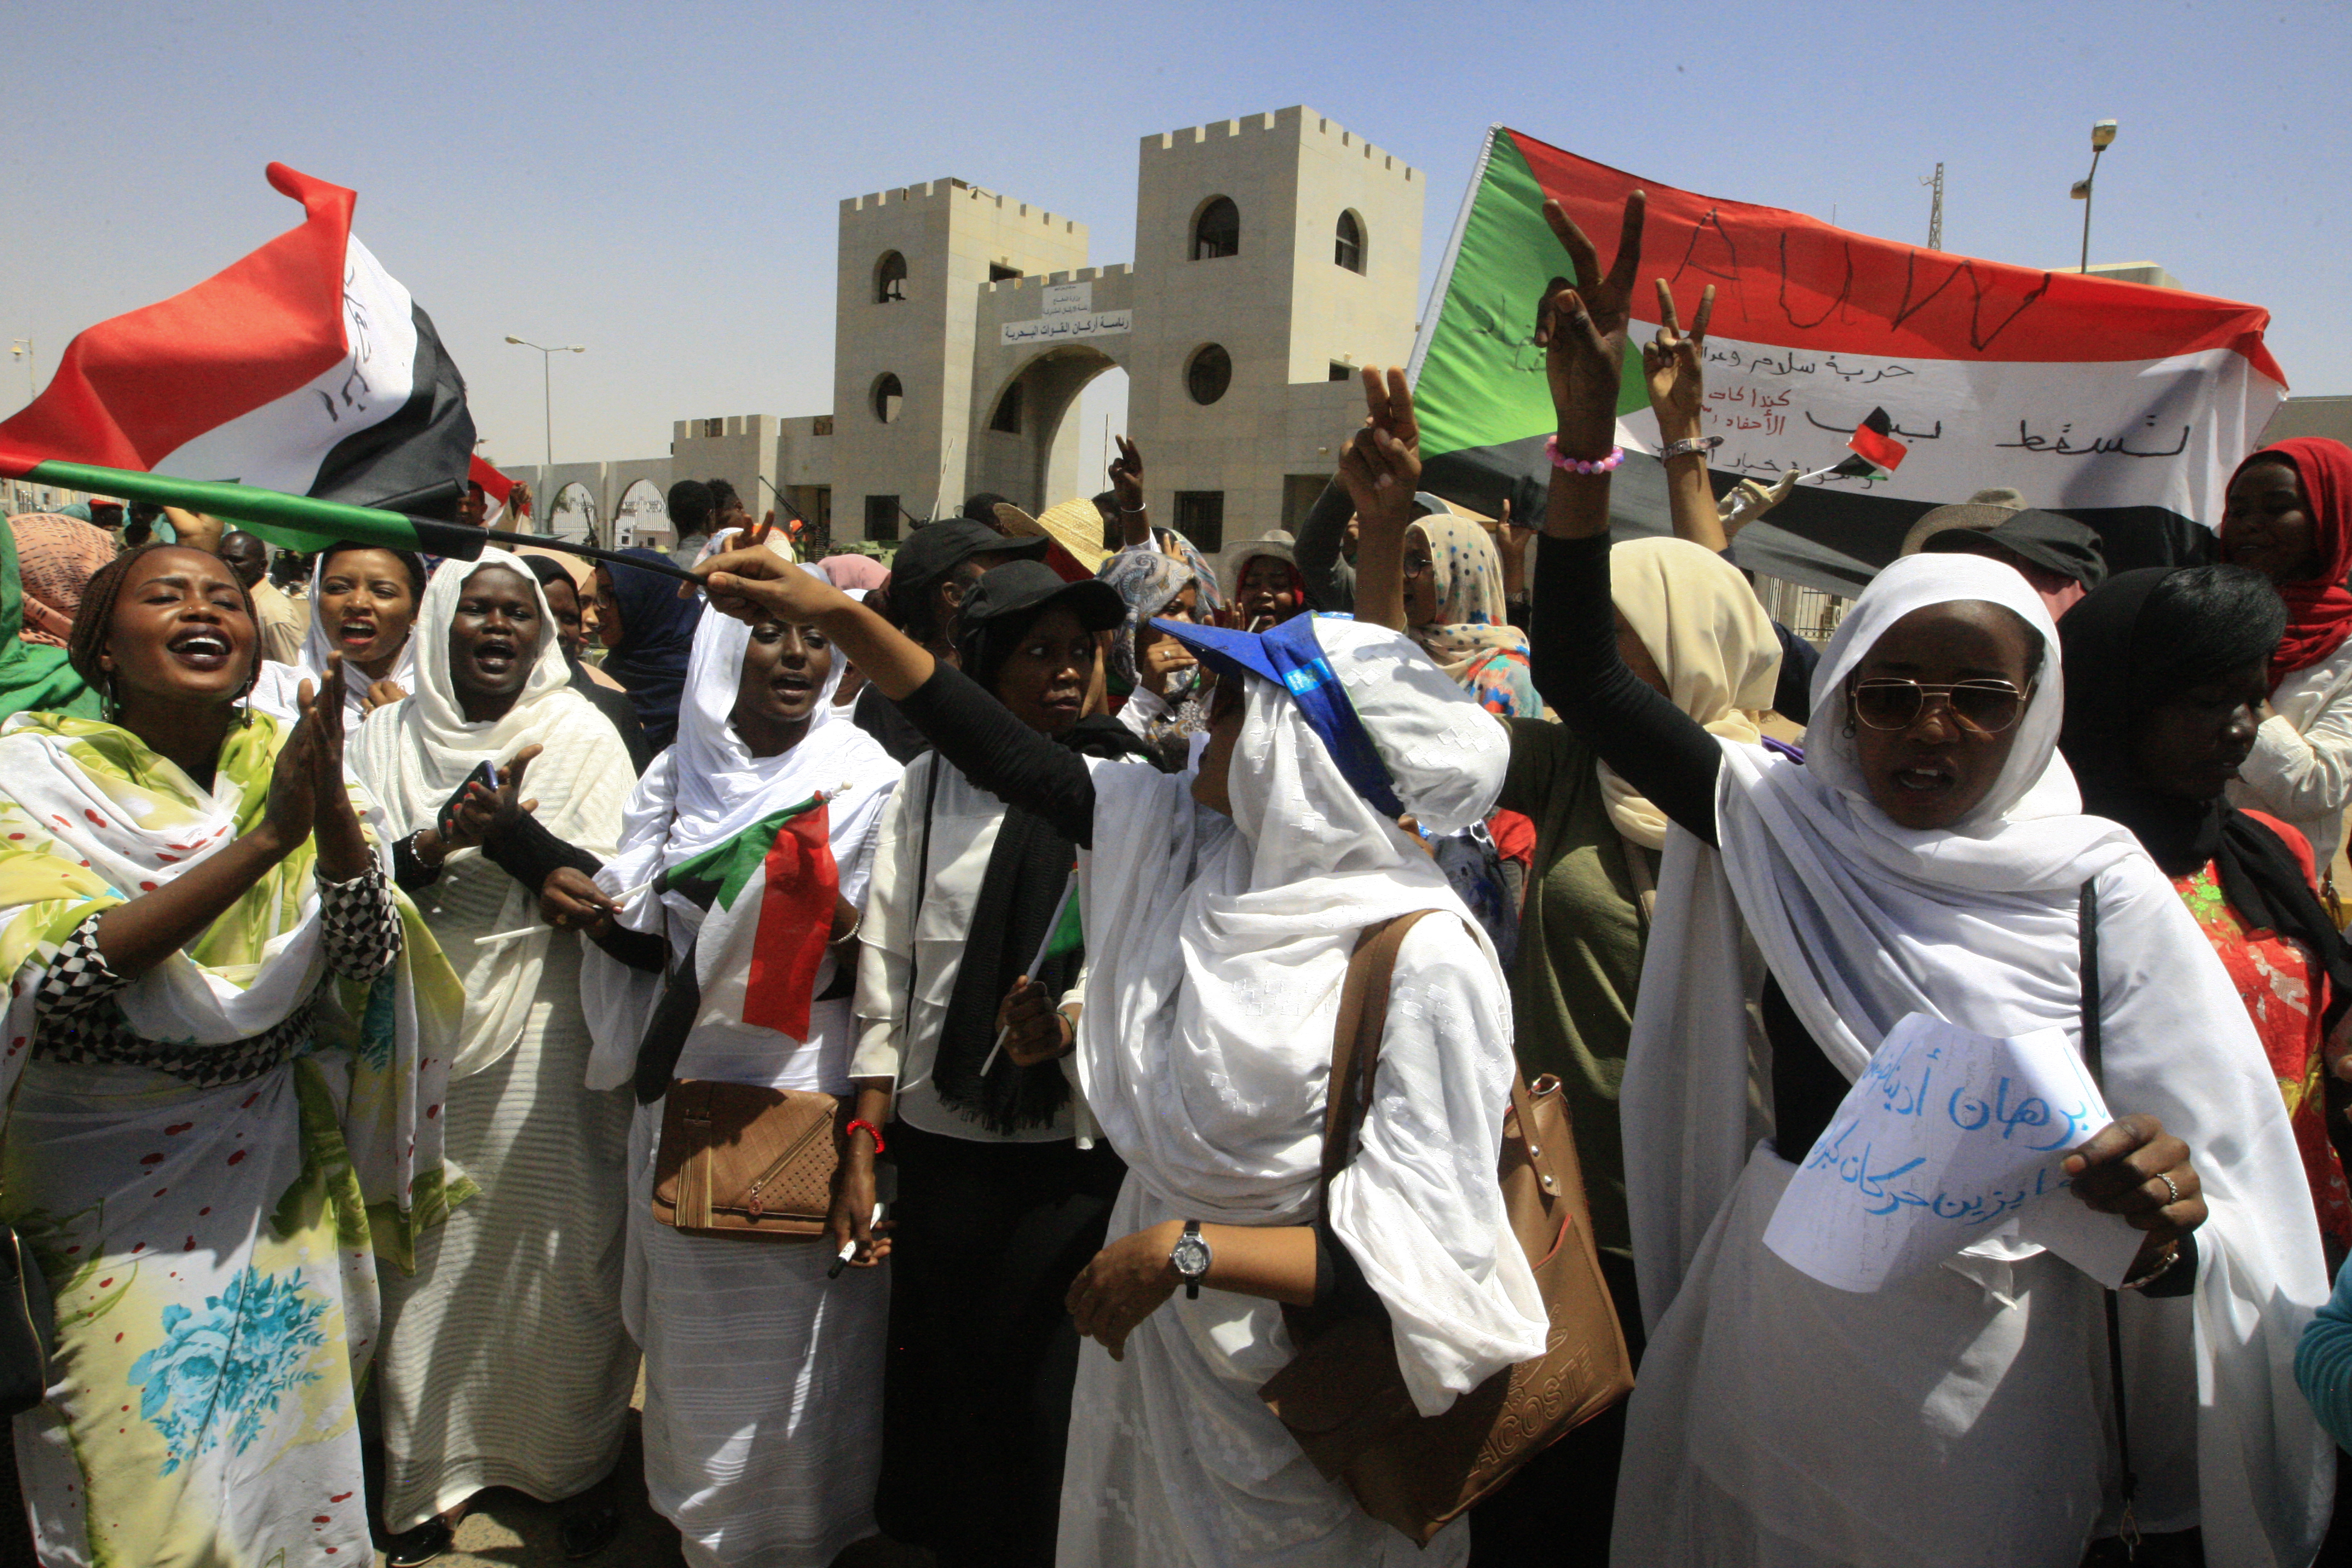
[0,162,485,560]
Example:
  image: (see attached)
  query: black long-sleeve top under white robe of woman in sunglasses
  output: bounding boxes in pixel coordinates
[1529,534,2197,1298]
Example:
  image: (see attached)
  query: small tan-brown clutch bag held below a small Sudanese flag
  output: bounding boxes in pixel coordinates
[654,1079,849,1241]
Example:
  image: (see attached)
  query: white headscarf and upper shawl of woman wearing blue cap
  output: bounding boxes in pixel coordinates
[1077,618,1543,1408]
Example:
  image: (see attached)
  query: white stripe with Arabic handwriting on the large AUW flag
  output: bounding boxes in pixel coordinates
[1621,322,2286,526]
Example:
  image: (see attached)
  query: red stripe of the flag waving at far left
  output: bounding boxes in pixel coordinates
[0,162,358,475]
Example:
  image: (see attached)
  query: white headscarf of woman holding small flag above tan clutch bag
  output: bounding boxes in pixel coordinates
[581,611,901,1088]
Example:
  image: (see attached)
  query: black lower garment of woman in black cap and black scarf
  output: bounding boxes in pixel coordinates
[875,1122,1126,1568]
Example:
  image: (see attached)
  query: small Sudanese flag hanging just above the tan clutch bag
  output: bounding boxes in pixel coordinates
[661,794,842,1039]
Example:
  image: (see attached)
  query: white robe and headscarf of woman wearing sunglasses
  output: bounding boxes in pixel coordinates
[1611,557,2333,1568]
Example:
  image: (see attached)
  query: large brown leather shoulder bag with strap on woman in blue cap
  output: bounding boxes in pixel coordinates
[1258,910,1632,1544]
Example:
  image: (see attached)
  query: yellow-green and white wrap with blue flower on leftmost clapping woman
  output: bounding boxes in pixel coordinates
[0,714,471,1568]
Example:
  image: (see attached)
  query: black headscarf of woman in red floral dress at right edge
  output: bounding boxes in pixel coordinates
[2058,567,2352,1034]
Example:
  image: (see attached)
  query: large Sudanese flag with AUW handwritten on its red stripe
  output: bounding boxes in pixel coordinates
[1411,127,2286,595]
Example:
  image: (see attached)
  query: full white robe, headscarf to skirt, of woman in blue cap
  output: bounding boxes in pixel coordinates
[1056,621,1545,1568]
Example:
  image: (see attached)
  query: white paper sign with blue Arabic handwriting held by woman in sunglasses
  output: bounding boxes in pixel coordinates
[1764,1013,2138,1293]
